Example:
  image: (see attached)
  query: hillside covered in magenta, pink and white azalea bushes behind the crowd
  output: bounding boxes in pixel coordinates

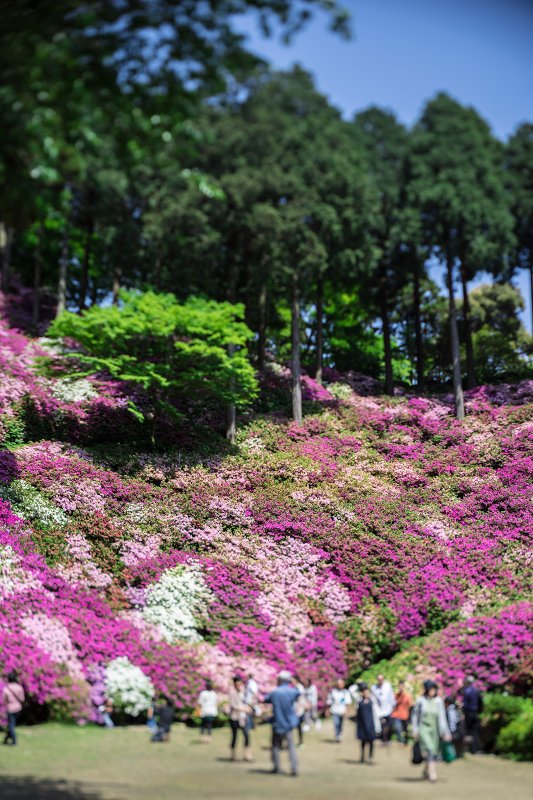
[0,318,533,720]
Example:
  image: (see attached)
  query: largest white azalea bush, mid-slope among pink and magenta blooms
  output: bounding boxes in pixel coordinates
[142,565,212,643]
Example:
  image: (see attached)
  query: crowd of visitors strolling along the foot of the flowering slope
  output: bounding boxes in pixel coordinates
[2,670,483,781]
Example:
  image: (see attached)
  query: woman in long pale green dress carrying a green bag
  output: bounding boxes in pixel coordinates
[413,681,452,783]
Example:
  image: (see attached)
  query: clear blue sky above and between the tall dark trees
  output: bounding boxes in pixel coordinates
[236,0,533,328]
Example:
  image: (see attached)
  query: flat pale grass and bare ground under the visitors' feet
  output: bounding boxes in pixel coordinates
[0,723,533,800]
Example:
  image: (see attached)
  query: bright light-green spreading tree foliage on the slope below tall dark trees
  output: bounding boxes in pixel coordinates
[48,291,257,432]
